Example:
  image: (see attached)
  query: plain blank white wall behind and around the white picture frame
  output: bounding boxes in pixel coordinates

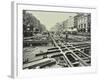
[0,0,100,80]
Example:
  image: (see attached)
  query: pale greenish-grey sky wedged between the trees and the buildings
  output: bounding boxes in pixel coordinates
[27,11,76,30]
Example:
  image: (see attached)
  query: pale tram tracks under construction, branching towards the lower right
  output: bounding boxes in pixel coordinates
[50,34,91,67]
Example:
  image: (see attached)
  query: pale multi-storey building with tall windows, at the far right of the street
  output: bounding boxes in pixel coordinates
[74,13,91,32]
